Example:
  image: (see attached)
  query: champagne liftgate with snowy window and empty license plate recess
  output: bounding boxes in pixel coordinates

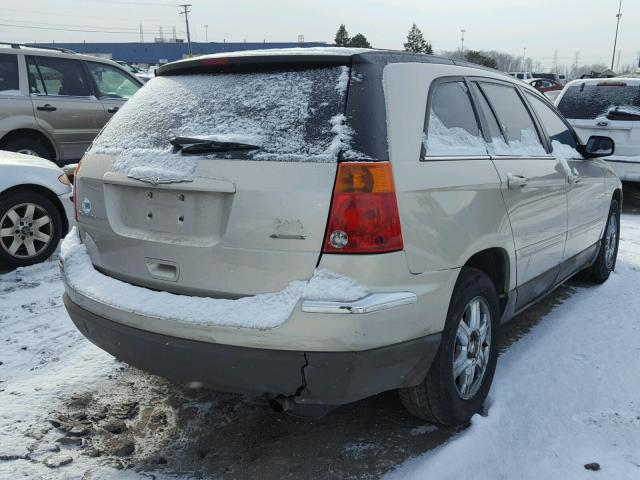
[77,65,356,296]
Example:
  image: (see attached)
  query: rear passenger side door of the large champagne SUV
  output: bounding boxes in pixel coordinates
[474,80,567,307]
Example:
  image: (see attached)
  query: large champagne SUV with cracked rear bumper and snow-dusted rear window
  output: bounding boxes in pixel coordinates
[61,49,622,424]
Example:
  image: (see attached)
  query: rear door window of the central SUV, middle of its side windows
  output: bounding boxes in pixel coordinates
[480,83,547,156]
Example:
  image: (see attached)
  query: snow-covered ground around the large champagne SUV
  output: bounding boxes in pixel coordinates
[0,215,640,480]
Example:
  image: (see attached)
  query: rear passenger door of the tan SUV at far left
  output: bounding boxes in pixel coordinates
[27,56,106,160]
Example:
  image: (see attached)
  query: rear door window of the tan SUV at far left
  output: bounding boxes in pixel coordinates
[29,57,91,97]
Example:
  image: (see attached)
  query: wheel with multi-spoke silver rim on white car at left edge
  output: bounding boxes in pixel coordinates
[0,190,62,267]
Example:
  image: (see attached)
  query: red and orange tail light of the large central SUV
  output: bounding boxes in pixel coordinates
[323,162,403,253]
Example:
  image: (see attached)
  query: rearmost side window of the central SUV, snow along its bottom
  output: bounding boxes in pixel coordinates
[423,82,487,157]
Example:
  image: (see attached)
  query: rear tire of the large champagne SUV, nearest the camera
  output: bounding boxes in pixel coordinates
[400,267,500,426]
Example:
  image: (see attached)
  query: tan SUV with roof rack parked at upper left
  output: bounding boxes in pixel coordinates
[0,44,142,164]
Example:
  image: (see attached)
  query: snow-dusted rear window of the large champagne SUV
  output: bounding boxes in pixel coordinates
[90,66,351,162]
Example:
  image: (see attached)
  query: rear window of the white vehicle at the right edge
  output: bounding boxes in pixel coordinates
[558,82,640,120]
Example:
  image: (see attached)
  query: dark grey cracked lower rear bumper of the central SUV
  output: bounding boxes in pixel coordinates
[64,294,441,405]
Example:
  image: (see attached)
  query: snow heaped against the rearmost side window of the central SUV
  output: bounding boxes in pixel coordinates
[422,111,487,157]
